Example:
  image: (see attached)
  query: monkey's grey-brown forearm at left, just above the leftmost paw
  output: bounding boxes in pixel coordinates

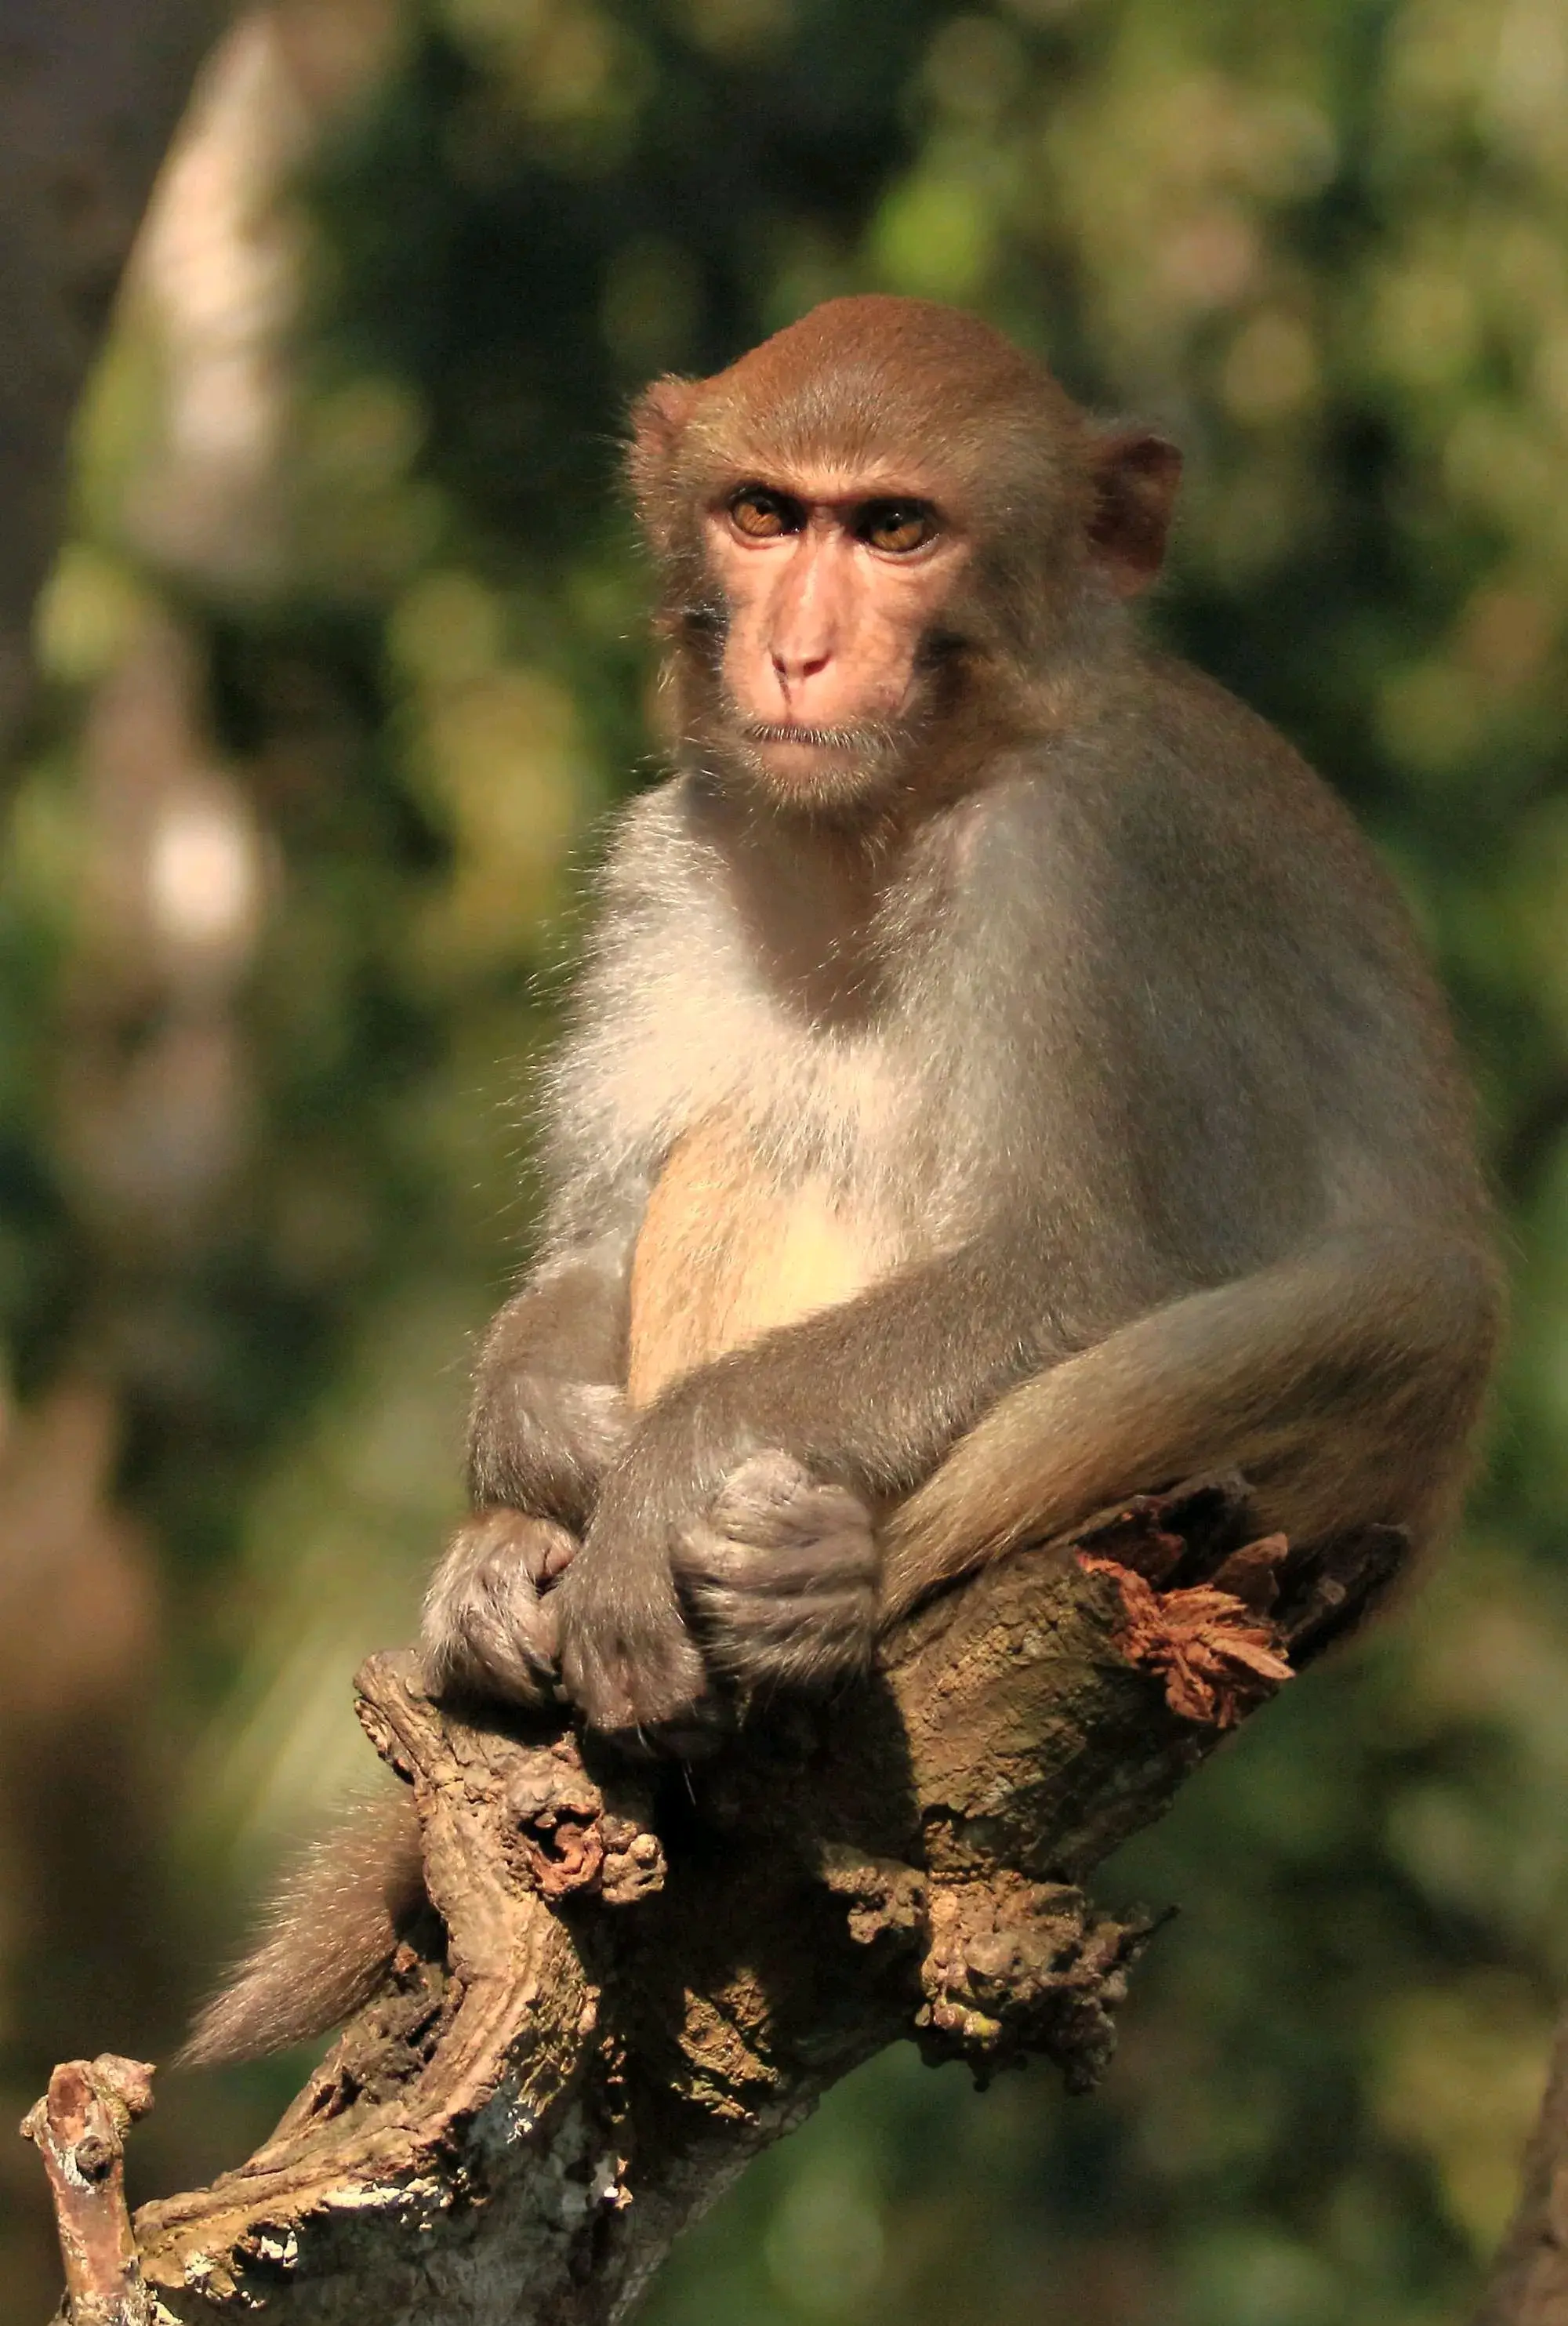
[467,1237,630,1528]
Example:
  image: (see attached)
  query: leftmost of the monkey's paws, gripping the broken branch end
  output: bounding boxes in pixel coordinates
[421,1508,577,1705]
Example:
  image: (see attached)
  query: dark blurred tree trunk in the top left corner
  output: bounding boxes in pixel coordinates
[0,0,226,765]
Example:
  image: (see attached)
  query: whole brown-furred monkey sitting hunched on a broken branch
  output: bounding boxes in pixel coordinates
[198,298,1498,2056]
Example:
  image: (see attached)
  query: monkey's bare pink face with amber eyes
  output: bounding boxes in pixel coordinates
[702,470,970,805]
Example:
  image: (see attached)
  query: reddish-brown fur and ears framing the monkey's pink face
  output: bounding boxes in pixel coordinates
[628,298,1179,800]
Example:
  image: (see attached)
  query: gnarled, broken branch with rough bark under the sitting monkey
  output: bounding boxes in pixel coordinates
[27,1479,1400,2326]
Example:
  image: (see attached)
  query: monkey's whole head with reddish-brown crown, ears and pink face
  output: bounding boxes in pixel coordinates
[630,298,1179,811]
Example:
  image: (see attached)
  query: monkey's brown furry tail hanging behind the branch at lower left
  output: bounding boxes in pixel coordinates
[179,1784,426,2068]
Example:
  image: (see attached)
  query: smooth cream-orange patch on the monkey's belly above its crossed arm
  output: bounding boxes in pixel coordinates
[626,1116,895,1405]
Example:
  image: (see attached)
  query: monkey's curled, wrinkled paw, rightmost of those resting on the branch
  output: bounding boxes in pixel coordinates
[677,1453,882,1686]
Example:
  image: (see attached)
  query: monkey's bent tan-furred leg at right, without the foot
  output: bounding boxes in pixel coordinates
[884,1228,1501,1617]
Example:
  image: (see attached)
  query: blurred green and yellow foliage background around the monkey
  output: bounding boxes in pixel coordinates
[0,0,1568,2326]
